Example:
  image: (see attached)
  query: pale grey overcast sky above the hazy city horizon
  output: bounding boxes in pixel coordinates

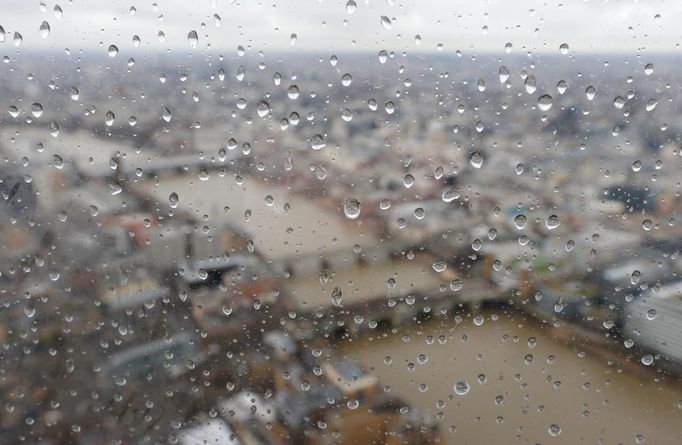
[0,0,682,55]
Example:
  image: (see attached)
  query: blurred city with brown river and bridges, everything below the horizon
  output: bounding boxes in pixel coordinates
[0,48,682,445]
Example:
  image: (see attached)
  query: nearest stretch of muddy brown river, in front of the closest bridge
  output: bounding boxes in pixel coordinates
[341,311,682,445]
